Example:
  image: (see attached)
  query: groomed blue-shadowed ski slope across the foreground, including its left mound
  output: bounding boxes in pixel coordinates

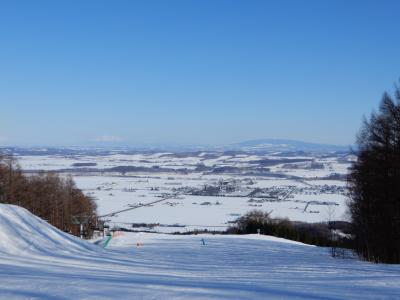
[0,204,400,299]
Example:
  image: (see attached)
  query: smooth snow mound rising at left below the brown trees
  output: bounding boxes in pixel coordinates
[0,204,99,255]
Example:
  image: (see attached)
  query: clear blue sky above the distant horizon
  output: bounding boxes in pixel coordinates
[0,0,400,145]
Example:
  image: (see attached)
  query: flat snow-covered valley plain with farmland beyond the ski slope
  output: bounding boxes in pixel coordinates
[18,151,353,232]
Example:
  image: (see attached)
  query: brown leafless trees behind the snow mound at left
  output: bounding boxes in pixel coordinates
[0,155,97,237]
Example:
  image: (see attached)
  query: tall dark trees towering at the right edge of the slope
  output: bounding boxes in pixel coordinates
[348,87,400,263]
